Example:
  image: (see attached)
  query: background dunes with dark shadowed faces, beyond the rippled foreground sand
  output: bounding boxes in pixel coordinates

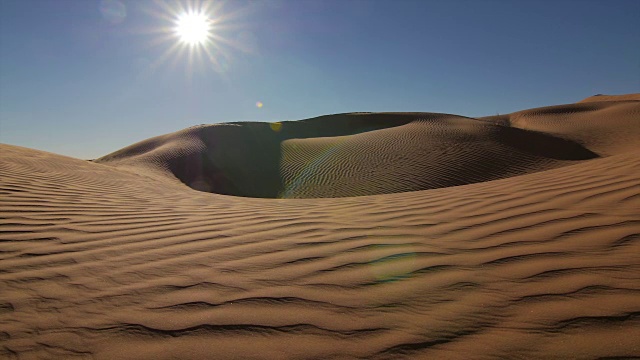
[91,102,624,198]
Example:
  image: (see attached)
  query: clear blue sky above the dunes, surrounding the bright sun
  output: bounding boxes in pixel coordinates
[0,0,640,159]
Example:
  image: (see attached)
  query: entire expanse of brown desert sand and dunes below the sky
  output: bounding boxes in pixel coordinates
[0,94,640,359]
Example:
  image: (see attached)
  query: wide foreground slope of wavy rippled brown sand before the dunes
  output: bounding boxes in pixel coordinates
[0,96,640,359]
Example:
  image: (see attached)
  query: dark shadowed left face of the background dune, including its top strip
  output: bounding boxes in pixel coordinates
[97,114,415,198]
